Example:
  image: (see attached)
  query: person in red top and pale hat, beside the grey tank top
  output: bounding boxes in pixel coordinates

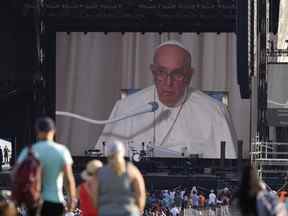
[77,160,103,216]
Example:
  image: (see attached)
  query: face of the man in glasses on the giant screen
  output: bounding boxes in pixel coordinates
[150,45,192,107]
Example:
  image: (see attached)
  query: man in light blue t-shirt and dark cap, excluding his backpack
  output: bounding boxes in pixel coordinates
[17,117,77,216]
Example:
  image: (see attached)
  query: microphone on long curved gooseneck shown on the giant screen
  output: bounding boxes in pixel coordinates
[56,101,159,124]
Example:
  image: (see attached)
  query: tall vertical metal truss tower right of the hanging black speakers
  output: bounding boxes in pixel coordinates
[248,0,269,160]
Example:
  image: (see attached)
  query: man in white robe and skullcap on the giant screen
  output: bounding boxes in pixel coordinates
[96,41,236,158]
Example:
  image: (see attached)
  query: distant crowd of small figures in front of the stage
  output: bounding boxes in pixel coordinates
[144,186,232,216]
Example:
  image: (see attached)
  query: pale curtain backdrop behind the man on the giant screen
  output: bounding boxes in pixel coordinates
[56,32,250,155]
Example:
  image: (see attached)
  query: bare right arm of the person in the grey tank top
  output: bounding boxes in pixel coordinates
[128,164,146,212]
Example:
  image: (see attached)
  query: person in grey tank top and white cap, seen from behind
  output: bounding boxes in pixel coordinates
[92,142,146,216]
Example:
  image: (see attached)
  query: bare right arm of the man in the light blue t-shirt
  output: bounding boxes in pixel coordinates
[64,164,77,211]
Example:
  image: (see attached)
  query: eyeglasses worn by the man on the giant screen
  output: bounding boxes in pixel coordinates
[151,65,187,82]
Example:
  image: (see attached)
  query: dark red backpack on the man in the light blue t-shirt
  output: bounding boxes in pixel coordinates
[12,146,42,208]
